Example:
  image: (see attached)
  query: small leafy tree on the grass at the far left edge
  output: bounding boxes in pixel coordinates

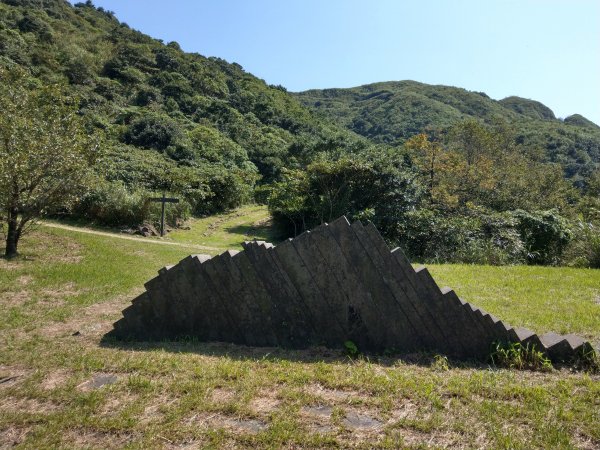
[0,69,96,258]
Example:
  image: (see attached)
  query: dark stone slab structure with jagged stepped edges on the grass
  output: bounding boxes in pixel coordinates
[109,217,593,362]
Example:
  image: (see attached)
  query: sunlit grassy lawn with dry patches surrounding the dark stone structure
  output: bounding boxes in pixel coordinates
[0,207,600,449]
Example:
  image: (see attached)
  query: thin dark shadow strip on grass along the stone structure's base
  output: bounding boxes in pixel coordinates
[100,334,490,370]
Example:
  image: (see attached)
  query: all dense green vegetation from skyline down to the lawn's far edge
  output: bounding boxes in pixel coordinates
[0,0,600,266]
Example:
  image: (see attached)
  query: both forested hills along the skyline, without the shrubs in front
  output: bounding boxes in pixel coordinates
[0,0,600,193]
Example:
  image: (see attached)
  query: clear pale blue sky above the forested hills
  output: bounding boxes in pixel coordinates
[84,0,600,124]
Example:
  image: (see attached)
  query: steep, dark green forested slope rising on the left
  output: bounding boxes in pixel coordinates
[0,0,365,220]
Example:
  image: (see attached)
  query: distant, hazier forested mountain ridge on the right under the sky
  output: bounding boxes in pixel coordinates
[295,81,600,183]
